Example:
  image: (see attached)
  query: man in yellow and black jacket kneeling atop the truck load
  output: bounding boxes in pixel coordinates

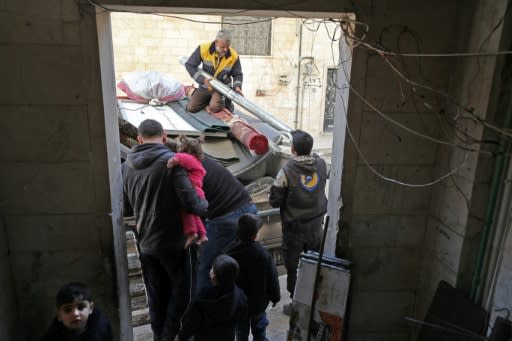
[185,30,244,113]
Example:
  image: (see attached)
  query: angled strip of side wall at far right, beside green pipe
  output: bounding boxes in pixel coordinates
[418,1,506,315]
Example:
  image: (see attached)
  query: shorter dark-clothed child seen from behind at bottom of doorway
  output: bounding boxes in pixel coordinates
[175,255,247,341]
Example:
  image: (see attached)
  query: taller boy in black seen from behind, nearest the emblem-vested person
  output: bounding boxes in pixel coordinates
[226,213,281,341]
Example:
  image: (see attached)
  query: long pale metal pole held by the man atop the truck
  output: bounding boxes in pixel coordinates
[180,58,293,133]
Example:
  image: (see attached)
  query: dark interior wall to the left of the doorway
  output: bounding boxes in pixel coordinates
[0,0,117,340]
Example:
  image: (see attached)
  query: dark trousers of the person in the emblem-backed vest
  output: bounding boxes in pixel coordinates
[283,215,323,297]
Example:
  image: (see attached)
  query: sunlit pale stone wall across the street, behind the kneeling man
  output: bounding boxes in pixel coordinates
[112,13,340,136]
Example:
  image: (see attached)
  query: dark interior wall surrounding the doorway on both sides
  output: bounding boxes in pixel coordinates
[0,0,508,341]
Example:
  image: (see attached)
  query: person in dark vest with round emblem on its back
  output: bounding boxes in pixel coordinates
[269,130,328,315]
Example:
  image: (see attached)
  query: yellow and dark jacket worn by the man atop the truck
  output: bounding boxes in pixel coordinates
[185,42,243,89]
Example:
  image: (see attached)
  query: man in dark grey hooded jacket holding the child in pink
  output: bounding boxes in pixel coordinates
[122,120,208,340]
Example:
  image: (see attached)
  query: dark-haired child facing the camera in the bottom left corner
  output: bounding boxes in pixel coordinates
[40,282,114,341]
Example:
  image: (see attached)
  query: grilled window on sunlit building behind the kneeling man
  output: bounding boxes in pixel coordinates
[222,17,272,56]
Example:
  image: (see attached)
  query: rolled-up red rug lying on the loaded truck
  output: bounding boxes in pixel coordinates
[210,109,268,155]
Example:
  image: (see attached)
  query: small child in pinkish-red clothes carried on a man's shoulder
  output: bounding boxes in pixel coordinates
[167,135,208,248]
